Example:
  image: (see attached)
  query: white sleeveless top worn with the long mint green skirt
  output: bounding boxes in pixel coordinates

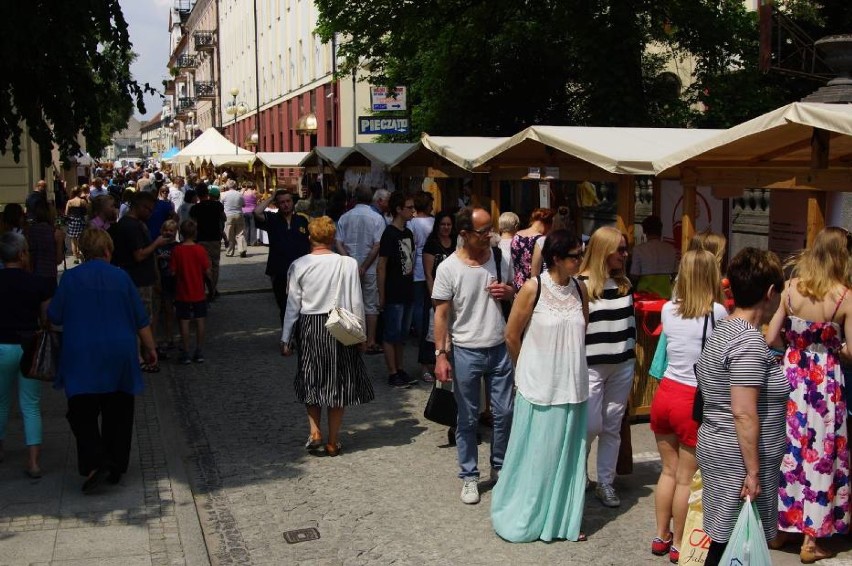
[515,271,589,405]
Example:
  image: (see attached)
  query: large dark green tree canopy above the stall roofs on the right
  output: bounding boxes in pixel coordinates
[316,0,852,137]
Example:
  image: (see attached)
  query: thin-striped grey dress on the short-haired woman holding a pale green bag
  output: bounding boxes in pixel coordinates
[696,318,790,542]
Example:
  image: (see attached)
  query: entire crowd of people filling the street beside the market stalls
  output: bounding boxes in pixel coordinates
[0,171,852,565]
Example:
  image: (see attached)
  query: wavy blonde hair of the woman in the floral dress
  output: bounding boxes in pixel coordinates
[788,227,852,301]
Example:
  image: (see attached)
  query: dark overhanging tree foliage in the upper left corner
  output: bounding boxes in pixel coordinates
[0,0,151,164]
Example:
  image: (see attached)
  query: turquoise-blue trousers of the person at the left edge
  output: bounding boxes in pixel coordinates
[0,344,41,446]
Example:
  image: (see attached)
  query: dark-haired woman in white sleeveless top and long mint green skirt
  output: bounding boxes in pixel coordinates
[491,230,589,542]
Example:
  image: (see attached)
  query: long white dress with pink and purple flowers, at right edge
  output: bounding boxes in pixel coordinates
[778,293,849,538]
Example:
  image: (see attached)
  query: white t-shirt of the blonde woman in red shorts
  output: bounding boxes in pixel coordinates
[661,301,728,387]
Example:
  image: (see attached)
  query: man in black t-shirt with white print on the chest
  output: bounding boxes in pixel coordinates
[376,191,417,387]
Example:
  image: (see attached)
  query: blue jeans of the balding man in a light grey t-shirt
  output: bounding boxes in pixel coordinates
[453,344,515,479]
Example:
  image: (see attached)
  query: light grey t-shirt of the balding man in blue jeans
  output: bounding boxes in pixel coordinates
[432,252,506,348]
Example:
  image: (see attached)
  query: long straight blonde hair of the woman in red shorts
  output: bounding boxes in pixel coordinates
[674,250,725,318]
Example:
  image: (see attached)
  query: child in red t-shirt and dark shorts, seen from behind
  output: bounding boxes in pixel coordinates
[169,220,211,364]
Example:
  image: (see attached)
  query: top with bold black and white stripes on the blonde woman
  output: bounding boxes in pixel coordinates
[577,276,636,366]
